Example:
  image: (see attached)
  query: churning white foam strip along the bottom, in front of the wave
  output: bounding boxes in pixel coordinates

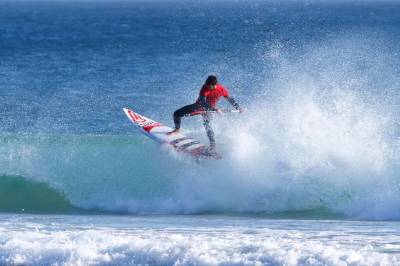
[0,216,400,265]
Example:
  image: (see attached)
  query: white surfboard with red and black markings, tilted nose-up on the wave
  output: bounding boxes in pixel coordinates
[123,108,221,159]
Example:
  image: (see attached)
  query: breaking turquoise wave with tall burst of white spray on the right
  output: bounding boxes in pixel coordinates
[0,84,400,220]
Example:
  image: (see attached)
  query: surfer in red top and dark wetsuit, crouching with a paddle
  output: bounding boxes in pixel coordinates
[169,75,243,152]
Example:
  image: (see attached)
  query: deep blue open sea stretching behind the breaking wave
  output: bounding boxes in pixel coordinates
[0,1,400,134]
